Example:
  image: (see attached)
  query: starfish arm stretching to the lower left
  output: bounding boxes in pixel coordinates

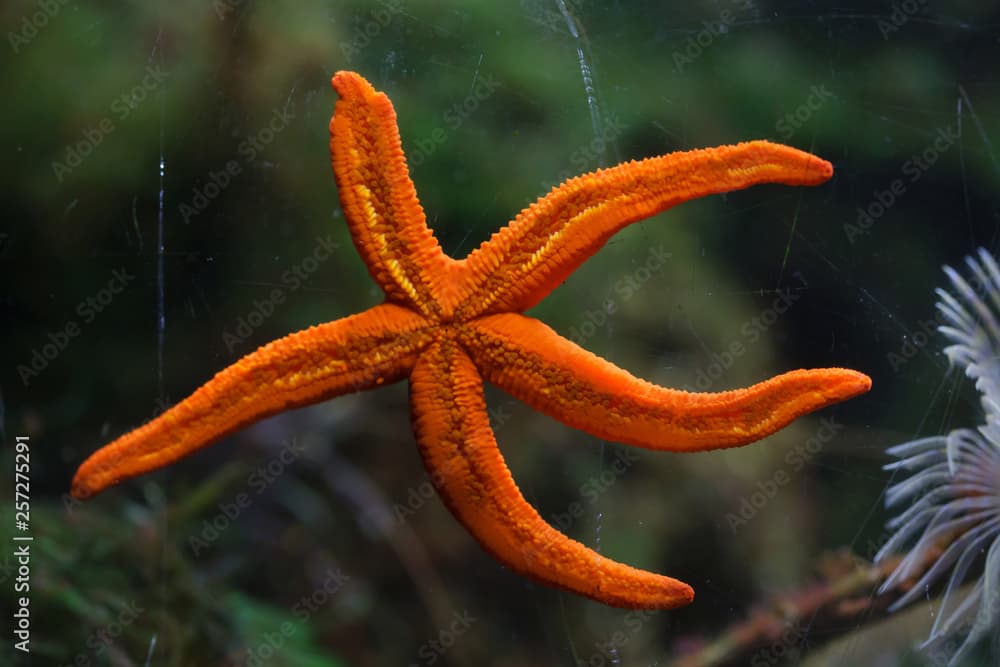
[72,304,431,498]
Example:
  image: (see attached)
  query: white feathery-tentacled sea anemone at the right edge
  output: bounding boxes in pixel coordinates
[875,248,1000,665]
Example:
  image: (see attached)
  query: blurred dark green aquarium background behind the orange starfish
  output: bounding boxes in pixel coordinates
[0,0,1000,666]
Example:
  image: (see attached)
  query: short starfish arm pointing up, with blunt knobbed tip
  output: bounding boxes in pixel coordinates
[330,72,454,315]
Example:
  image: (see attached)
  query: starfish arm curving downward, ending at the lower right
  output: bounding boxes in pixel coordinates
[410,339,694,609]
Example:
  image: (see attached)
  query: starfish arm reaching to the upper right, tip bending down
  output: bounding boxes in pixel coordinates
[456,141,833,316]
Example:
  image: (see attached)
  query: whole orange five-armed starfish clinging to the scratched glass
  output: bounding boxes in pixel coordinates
[72,72,871,609]
